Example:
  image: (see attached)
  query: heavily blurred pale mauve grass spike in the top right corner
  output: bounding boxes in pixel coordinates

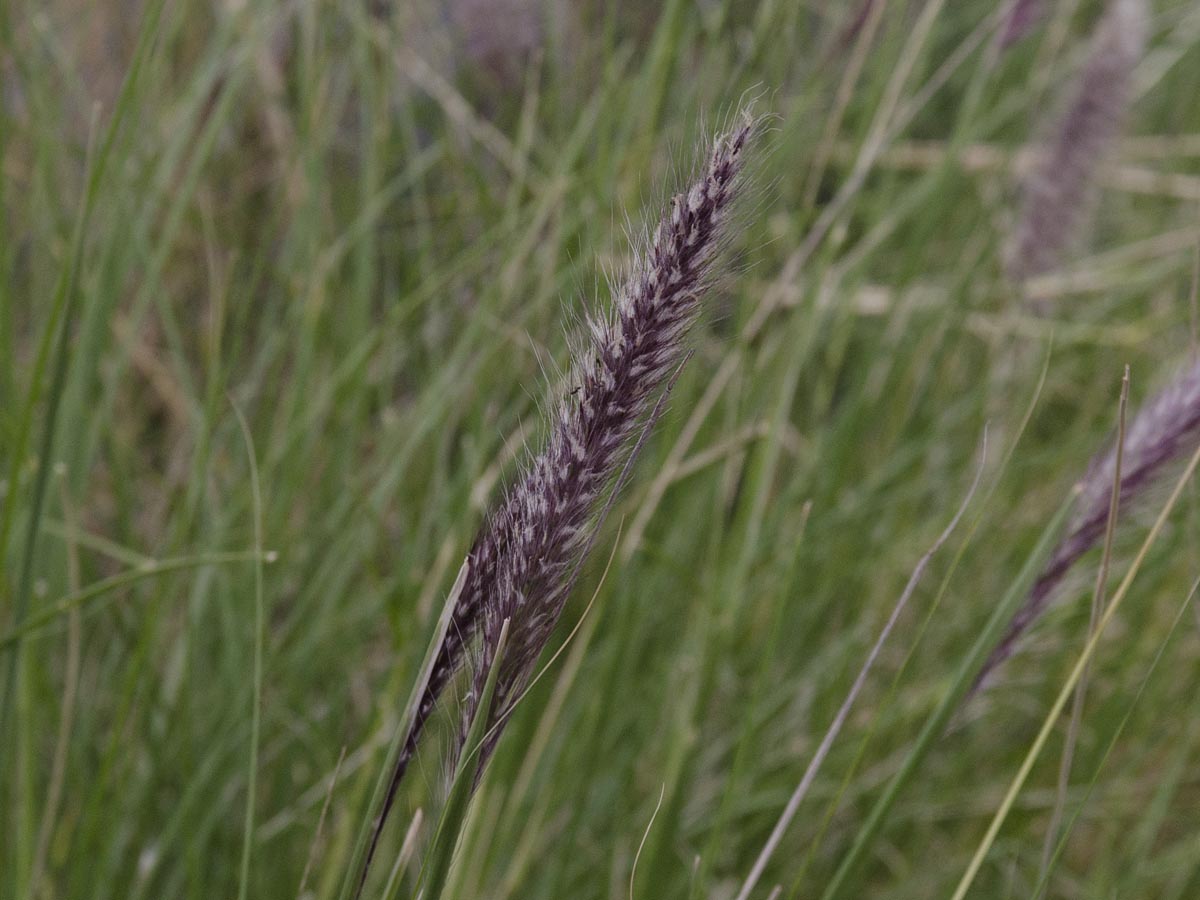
[1007,0,1146,282]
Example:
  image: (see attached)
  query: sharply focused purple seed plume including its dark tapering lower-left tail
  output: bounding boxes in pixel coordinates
[355,110,761,894]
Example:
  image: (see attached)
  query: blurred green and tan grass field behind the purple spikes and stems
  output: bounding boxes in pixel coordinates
[0,0,1200,900]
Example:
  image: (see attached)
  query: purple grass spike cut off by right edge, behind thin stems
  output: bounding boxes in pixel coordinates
[976,364,1200,689]
